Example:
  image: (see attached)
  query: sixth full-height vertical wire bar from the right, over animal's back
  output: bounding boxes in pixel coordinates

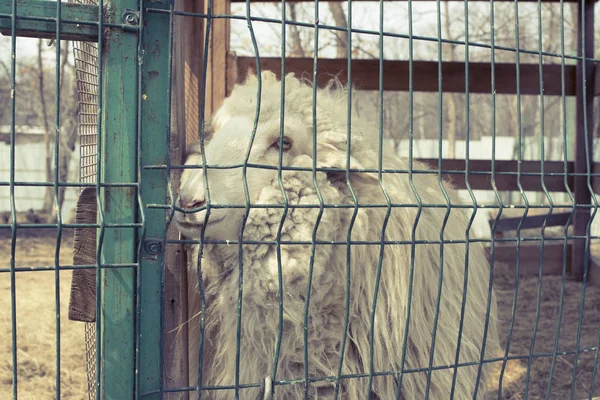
[450,0,477,397]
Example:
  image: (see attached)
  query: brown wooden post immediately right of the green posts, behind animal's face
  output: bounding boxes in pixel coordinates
[164,0,230,390]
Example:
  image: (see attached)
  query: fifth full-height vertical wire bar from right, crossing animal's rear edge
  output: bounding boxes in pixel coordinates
[473,0,504,399]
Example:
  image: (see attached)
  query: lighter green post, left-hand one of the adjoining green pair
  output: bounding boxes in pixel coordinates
[97,0,138,400]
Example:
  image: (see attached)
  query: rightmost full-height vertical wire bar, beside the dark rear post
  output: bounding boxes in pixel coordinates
[571,0,598,398]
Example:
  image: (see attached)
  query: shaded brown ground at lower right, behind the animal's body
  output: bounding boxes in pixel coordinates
[492,266,600,400]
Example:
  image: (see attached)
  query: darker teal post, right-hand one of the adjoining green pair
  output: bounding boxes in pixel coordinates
[137,0,172,400]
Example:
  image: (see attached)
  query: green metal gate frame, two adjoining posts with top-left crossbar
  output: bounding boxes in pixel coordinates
[0,0,173,399]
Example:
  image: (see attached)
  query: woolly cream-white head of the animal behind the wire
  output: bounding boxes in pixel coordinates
[176,73,375,240]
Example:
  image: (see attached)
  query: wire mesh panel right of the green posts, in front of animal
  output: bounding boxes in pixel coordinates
[163,1,600,398]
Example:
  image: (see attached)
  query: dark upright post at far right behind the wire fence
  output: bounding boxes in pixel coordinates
[571,0,594,280]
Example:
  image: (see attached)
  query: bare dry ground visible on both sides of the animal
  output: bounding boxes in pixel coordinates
[0,231,600,400]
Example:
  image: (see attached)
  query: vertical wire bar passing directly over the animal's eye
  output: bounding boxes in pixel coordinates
[272,0,289,397]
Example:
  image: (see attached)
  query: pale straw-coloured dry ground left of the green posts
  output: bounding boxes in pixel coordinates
[0,231,87,400]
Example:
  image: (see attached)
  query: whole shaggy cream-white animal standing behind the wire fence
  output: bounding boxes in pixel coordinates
[176,72,499,400]
